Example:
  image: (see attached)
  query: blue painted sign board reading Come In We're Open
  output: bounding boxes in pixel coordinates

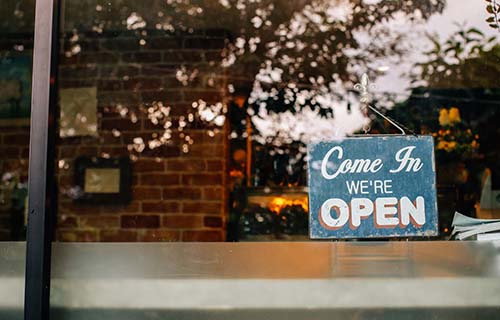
[308,136,438,239]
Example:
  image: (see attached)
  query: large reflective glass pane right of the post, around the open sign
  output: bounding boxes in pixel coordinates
[56,0,500,241]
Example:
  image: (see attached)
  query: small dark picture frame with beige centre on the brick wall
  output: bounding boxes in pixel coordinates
[75,157,132,204]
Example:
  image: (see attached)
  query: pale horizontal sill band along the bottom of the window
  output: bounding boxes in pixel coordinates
[0,241,500,319]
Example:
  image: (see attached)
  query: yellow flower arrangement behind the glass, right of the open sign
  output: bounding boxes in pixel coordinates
[433,107,479,161]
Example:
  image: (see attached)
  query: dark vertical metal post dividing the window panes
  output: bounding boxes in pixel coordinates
[24,0,58,320]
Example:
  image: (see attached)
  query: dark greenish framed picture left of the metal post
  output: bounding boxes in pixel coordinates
[0,52,32,126]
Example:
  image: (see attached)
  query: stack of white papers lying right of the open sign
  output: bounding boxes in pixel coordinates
[451,212,500,240]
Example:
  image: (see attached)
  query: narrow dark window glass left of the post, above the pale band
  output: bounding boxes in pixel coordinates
[0,1,34,241]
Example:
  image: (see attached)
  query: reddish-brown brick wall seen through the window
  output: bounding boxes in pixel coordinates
[2,30,228,241]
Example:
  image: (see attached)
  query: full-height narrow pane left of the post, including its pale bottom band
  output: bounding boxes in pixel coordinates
[0,0,34,319]
